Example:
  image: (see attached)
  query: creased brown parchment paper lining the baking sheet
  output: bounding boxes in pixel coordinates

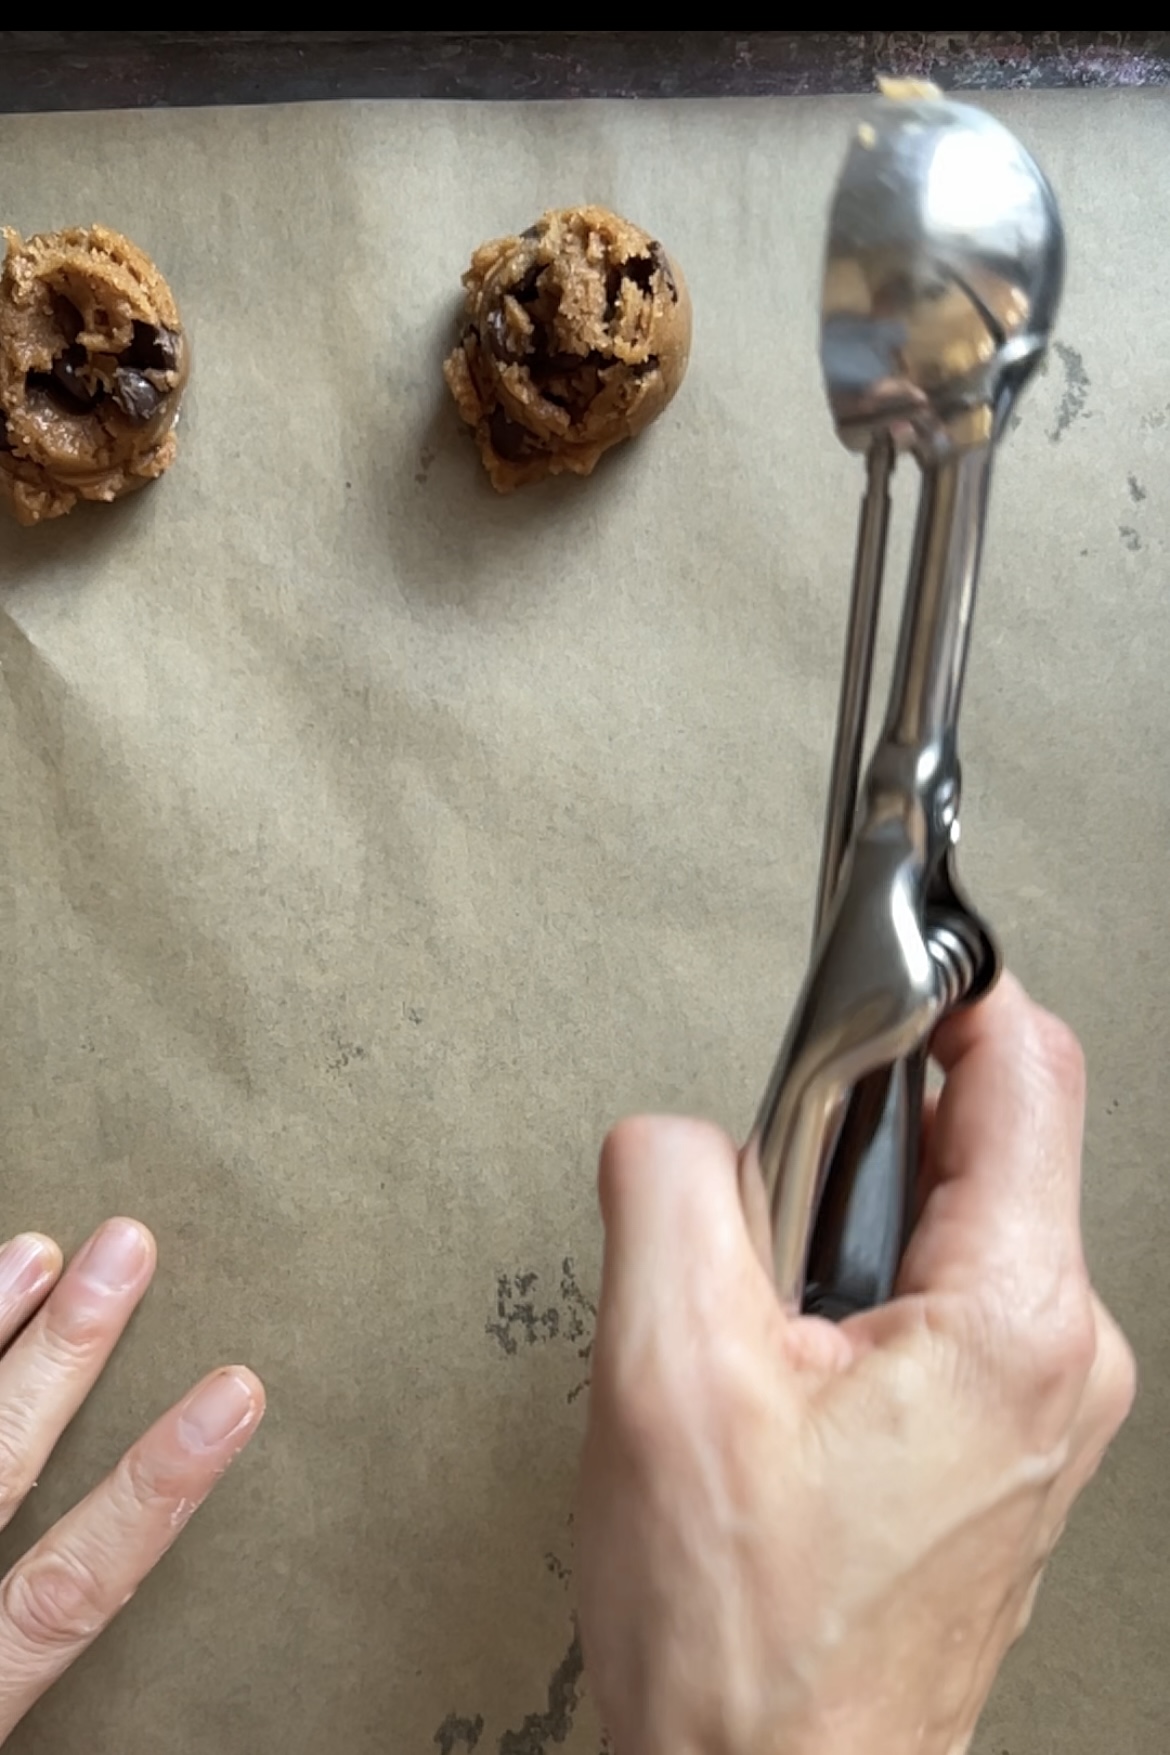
[0,91,1170,1755]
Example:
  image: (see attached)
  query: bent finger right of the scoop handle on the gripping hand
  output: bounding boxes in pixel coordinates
[898,976,1084,1307]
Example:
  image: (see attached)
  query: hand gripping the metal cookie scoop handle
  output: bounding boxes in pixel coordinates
[577,978,1135,1755]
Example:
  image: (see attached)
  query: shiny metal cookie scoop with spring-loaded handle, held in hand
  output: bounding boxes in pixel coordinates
[744,91,1065,1316]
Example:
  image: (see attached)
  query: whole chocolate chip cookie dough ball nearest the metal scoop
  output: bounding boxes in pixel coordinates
[444,207,691,493]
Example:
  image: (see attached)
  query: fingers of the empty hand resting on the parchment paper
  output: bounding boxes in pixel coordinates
[0,1220,263,1743]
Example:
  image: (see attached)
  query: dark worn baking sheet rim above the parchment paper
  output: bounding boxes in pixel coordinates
[0,30,1170,114]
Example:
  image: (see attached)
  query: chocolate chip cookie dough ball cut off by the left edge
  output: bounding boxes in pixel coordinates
[0,225,189,525]
